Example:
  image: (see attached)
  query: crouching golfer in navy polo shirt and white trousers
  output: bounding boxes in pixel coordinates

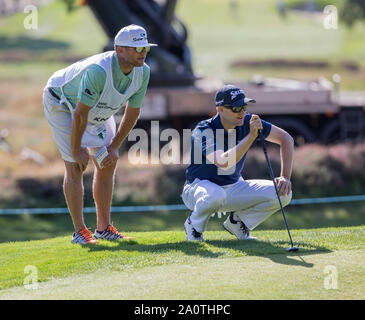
[182,85,294,241]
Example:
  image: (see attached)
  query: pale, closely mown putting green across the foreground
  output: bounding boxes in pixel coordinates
[0,250,365,300]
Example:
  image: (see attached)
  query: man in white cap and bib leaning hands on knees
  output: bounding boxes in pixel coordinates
[43,25,156,244]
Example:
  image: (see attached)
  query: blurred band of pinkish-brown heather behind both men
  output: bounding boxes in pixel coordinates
[0,143,365,208]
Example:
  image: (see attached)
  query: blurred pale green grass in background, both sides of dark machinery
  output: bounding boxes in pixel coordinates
[0,0,365,90]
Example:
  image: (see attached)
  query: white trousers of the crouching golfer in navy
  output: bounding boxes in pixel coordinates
[181,178,292,232]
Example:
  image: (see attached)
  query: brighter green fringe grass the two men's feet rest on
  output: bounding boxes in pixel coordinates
[0,226,365,290]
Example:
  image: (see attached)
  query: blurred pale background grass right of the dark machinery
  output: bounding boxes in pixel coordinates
[177,0,365,90]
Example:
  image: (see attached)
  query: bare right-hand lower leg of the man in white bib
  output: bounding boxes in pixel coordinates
[92,157,116,231]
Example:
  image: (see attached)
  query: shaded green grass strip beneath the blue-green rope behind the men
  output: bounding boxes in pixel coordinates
[0,199,365,243]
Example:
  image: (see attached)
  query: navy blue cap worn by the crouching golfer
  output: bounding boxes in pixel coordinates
[215,84,256,107]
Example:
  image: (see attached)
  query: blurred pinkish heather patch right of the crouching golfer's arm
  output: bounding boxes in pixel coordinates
[293,143,365,197]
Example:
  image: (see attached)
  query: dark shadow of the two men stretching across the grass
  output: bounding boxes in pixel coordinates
[84,240,332,268]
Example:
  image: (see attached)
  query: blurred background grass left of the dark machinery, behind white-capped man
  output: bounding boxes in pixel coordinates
[0,1,108,82]
